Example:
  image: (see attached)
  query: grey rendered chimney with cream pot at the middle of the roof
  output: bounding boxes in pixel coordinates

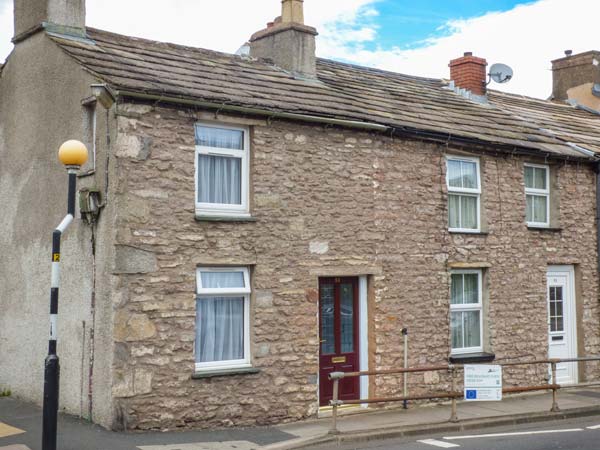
[250,0,318,79]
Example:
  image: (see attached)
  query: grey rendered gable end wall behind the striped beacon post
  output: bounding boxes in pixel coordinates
[0,32,112,425]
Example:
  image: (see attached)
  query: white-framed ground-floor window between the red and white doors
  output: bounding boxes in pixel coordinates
[450,270,483,355]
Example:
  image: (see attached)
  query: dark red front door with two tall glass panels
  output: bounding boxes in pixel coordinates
[319,277,360,406]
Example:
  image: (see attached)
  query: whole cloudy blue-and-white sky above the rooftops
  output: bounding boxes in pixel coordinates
[0,0,600,98]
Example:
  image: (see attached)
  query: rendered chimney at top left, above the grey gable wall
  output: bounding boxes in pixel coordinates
[13,0,85,42]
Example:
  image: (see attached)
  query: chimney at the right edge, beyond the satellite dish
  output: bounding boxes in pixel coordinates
[552,50,600,110]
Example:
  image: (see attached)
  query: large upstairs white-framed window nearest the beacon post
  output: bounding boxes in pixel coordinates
[195,123,250,216]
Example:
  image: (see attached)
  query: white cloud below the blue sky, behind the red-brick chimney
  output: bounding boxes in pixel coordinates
[314,0,600,98]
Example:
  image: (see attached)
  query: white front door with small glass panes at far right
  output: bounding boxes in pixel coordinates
[547,266,578,384]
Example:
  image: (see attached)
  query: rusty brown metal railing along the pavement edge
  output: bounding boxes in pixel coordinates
[328,356,600,434]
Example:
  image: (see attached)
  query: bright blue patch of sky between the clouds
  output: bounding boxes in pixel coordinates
[366,0,530,49]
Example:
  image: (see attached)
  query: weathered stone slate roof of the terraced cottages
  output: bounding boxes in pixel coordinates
[51,28,600,158]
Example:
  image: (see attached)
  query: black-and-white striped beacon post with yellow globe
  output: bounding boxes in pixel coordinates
[42,141,88,450]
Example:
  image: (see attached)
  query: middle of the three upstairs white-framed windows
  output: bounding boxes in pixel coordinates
[446,156,481,233]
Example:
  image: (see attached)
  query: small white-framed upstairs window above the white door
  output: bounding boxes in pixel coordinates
[525,164,550,227]
